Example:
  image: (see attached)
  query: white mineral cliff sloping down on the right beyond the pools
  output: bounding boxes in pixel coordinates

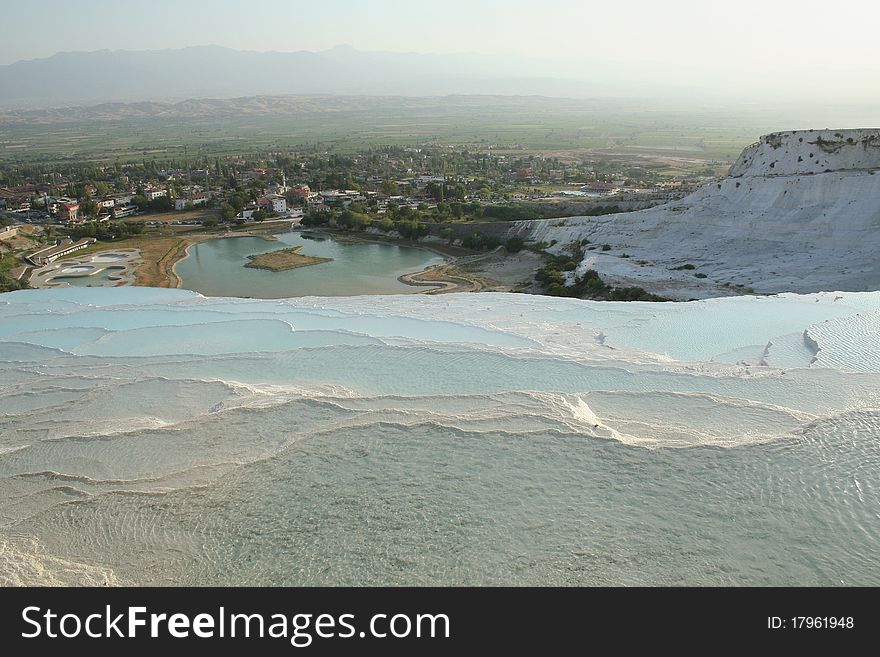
[511,129,880,299]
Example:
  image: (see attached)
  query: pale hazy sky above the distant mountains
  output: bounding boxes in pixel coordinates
[0,0,880,100]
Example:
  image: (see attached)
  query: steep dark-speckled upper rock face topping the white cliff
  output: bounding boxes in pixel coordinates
[730,129,880,177]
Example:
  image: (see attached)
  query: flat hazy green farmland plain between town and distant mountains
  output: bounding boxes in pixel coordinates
[0,97,780,165]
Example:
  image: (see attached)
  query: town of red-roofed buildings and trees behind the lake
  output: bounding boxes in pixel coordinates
[0,145,718,289]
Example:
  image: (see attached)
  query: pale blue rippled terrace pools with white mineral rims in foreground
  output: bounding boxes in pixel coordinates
[0,288,880,585]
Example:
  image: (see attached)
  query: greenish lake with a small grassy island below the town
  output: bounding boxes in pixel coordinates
[175,231,445,299]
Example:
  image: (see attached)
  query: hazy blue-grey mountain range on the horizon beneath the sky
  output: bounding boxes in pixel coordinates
[0,46,599,108]
